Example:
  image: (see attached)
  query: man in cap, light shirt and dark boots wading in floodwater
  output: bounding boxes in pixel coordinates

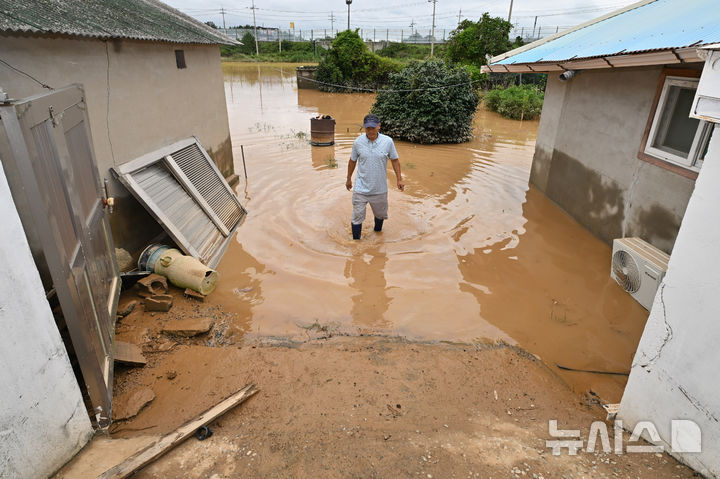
[345,114,405,240]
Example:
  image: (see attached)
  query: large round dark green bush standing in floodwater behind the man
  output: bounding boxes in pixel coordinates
[372,60,479,143]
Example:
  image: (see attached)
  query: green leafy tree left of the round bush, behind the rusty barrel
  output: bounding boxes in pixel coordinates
[315,30,402,92]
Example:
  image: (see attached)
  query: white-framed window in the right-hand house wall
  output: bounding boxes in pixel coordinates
[645,76,713,171]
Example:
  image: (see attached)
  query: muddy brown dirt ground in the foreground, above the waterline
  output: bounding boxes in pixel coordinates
[57,290,693,479]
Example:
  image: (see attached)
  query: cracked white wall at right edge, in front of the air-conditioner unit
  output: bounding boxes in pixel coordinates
[618,126,720,478]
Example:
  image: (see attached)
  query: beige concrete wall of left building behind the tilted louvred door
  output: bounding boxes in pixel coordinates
[0,35,234,251]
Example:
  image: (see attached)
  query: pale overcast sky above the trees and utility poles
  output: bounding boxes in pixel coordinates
[164,0,633,32]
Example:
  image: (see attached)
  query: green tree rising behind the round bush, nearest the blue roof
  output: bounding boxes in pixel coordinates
[445,13,513,67]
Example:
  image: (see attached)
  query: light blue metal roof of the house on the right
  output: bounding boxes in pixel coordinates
[492,0,720,65]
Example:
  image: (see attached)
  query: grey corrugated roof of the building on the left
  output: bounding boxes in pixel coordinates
[0,0,238,45]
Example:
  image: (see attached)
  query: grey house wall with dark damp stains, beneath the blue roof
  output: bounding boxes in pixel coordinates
[530,64,702,253]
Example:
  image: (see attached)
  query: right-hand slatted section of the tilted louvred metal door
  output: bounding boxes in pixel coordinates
[170,144,243,229]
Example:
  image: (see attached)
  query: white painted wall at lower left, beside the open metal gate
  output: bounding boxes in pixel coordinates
[0,164,93,478]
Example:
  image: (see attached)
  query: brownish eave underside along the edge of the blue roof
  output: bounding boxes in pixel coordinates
[482,47,703,73]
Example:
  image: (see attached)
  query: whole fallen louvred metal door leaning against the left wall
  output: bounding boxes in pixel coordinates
[113,138,247,268]
